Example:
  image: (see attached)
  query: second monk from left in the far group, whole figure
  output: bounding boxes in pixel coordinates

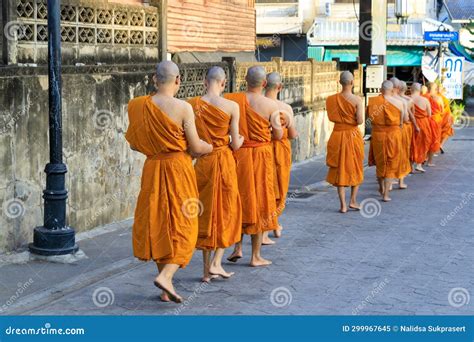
[367,81,403,202]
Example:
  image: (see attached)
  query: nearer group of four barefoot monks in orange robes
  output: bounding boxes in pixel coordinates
[126,61,297,303]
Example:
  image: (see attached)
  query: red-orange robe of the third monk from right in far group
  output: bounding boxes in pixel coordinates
[412,104,432,164]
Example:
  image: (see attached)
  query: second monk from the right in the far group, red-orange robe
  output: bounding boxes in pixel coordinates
[424,82,444,166]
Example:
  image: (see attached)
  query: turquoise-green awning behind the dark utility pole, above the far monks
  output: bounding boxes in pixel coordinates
[308,46,423,66]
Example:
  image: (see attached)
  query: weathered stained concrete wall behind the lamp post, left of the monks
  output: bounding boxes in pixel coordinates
[0,67,153,253]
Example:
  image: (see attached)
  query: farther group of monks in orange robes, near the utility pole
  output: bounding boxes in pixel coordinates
[326,71,454,213]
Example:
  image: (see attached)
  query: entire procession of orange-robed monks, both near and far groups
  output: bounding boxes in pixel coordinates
[126,61,452,303]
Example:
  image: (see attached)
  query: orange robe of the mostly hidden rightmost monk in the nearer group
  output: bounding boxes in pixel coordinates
[273,115,291,215]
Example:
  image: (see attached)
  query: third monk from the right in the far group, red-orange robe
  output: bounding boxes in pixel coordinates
[411,83,432,172]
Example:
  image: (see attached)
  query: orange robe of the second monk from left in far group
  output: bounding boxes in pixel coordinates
[368,95,402,178]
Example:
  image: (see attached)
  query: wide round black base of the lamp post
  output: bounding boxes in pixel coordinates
[28,227,79,256]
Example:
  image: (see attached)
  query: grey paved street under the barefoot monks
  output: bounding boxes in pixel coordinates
[0,117,474,315]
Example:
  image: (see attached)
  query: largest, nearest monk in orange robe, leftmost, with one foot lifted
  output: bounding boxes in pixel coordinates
[126,61,212,303]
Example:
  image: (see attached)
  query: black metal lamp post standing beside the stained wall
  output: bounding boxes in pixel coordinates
[29,0,78,256]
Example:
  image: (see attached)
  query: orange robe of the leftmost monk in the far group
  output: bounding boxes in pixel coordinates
[326,94,364,186]
